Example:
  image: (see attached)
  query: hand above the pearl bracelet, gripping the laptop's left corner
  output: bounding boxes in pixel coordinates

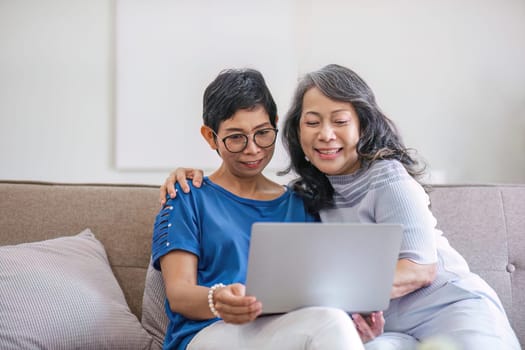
[213,283,262,324]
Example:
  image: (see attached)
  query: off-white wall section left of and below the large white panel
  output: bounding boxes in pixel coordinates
[0,0,166,183]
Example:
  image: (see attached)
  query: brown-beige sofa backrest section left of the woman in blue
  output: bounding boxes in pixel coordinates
[0,181,160,319]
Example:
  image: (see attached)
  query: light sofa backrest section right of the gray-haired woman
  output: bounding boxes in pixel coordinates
[430,185,525,344]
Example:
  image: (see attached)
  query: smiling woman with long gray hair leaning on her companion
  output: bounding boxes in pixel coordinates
[283,64,520,349]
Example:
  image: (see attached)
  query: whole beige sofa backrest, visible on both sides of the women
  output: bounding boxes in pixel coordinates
[0,181,525,344]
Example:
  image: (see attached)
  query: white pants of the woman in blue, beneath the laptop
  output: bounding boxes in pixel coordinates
[187,307,364,350]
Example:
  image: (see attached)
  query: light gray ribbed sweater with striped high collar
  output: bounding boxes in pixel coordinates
[320,160,494,299]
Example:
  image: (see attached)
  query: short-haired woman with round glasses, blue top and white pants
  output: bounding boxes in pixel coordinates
[152,69,384,350]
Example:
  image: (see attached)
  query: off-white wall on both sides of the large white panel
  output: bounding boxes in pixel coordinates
[0,0,525,184]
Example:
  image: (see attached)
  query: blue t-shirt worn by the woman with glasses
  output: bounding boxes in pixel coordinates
[152,177,315,349]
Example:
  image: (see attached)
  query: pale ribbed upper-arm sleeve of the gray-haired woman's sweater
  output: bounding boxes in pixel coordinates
[374,174,437,264]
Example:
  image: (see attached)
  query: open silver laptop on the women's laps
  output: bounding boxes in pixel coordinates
[246,222,403,314]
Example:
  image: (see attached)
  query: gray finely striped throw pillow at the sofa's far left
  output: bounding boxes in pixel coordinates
[0,230,152,350]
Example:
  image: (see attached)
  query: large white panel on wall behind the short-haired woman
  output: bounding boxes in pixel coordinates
[116,0,298,170]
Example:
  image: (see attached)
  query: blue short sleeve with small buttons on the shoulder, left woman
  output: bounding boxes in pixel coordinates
[151,186,200,270]
